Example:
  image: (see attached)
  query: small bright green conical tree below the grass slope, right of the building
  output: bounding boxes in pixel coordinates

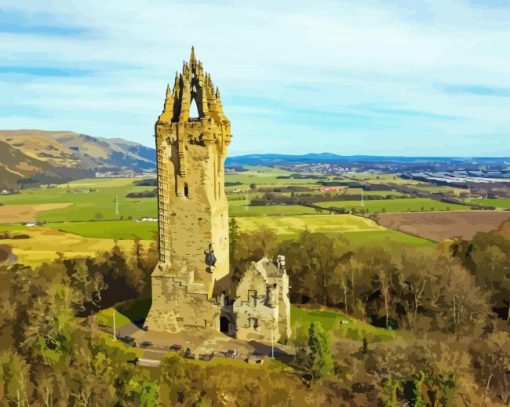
[308,322,333,380]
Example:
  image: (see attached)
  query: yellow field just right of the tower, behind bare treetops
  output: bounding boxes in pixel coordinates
[236,215,386,235]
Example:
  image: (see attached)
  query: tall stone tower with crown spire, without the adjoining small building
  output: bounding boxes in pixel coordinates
[147,48,231,331]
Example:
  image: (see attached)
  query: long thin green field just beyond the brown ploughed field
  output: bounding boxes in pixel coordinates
[316,198,470,213]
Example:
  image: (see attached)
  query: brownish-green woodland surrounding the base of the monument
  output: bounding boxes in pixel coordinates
[0,220,510,406]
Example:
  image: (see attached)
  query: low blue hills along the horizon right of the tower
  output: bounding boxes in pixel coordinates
[226,153,510,166]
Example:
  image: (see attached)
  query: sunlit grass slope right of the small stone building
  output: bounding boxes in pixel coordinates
[290,305,396,342]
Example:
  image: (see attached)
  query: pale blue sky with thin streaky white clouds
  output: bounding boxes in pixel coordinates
[0,0,510,157]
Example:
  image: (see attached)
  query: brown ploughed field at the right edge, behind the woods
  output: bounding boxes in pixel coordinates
[377,211,510,241]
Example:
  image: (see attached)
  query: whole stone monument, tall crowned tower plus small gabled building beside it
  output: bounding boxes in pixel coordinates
[145,48,291,341]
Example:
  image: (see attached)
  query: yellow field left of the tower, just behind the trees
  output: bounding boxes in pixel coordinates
[0,227,149,266]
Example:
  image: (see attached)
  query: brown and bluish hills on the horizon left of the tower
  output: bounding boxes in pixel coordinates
[0,130,156,188]
